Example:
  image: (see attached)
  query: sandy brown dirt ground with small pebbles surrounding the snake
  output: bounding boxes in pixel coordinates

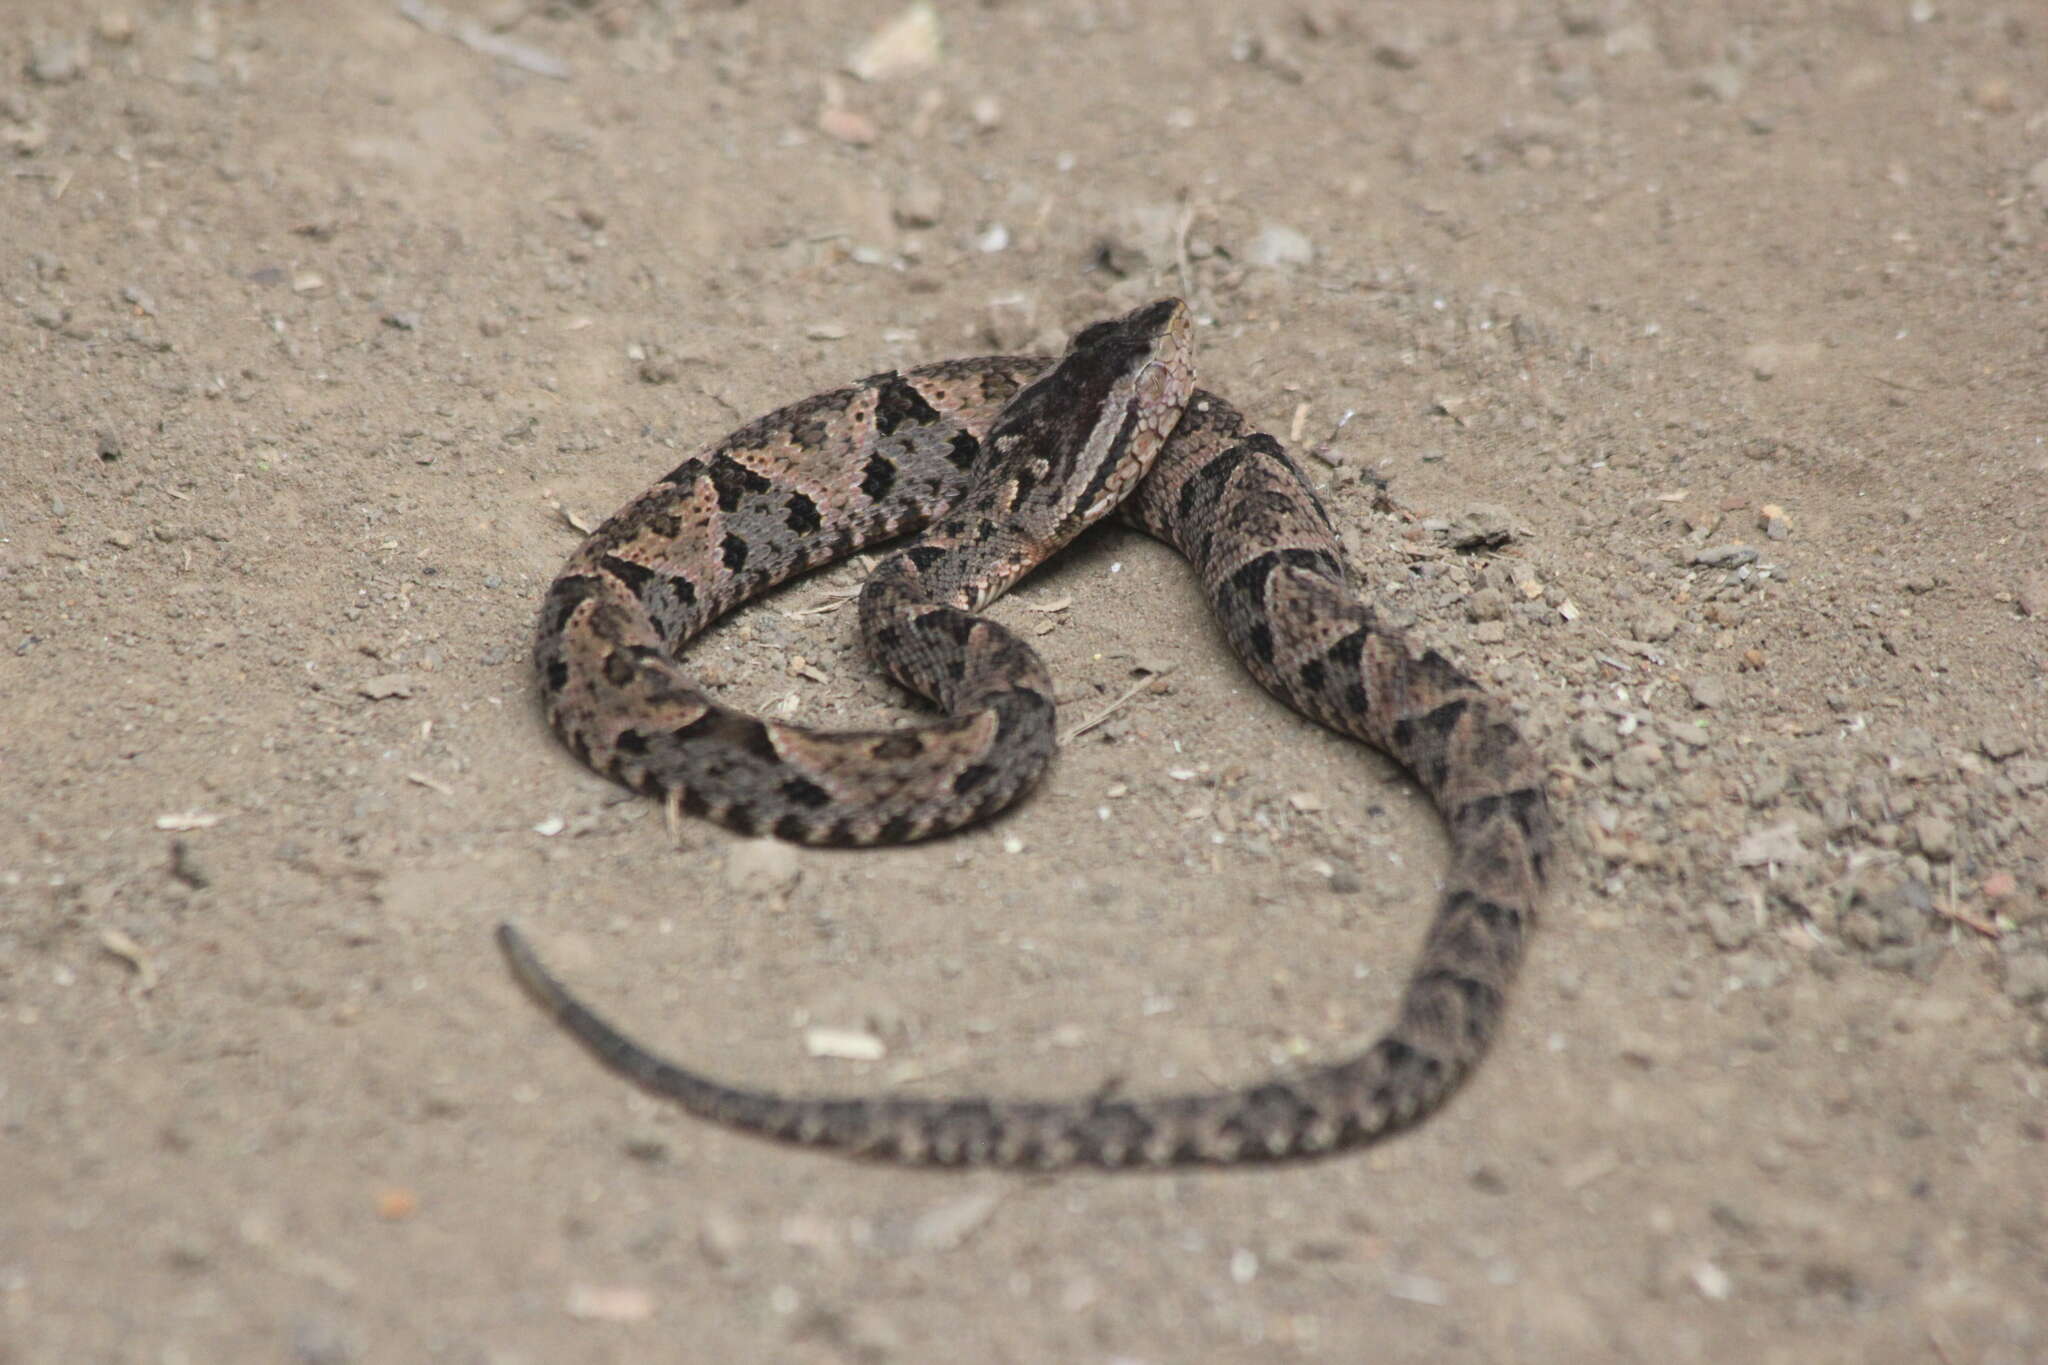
[0,0,2048,1365]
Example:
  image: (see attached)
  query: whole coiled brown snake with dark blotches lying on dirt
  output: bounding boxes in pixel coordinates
[498,299,1554,1171]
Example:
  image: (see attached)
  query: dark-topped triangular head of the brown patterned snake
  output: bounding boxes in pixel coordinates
[979,299,1194,555]
